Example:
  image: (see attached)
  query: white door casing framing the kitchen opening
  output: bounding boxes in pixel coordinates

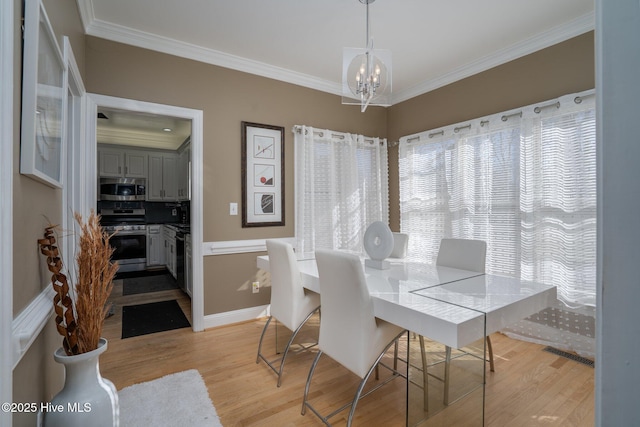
[86,94,204,331]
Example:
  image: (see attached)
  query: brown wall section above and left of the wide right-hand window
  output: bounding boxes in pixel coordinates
[387,32,595,230]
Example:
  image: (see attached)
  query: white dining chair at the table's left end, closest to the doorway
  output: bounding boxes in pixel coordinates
[256,239,320,387]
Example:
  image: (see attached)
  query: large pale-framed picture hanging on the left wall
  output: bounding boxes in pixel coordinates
[20,0,67,188]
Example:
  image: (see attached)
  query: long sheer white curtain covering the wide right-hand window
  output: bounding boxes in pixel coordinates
[399,91,596,355]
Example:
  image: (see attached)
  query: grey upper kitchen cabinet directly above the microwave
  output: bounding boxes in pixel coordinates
[98,147,148,178]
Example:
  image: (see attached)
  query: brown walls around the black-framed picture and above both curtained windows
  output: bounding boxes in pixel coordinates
[85,33,594,315]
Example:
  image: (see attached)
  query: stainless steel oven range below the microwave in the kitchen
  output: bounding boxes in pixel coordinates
[100,202,147,273]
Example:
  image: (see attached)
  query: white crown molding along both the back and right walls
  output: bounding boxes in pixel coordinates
[77,0,595,104]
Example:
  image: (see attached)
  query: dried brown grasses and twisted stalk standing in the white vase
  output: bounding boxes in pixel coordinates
[38,210,118,356]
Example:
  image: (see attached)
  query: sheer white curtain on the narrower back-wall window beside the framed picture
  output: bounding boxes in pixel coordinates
[293,126,389,253]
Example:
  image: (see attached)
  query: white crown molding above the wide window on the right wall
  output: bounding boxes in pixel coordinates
[393,12,595,104]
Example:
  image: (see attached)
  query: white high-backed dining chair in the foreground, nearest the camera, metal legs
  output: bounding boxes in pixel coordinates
[302,249,405,426]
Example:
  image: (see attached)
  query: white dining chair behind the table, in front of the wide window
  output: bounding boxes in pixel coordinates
[428,239,495,405]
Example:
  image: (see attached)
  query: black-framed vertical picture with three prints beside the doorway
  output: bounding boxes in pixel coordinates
[241,121,285,227]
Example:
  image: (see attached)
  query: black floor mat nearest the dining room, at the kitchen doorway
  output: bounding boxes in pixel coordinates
[122,300,191,339]
